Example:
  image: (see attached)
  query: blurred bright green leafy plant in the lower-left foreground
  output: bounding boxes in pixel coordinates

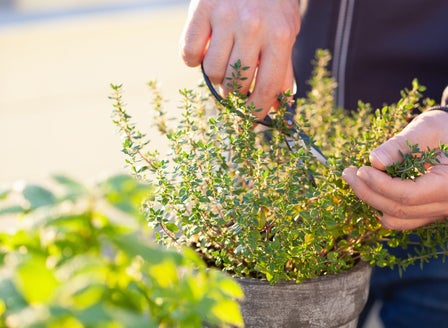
[0,175,242,327]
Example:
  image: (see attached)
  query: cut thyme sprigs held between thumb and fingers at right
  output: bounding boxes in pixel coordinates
[386,142,448,180]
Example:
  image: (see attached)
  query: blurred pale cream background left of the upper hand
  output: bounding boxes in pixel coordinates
[0,0,200,185]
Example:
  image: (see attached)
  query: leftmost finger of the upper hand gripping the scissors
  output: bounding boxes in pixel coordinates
[181,1,212,67]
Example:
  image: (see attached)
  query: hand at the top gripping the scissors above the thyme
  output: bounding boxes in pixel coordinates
[181,0,300,118]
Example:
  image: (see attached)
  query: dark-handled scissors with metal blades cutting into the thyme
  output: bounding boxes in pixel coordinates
[201,65,327,169]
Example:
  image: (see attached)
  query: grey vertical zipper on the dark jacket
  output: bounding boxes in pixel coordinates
[331,0,355,108]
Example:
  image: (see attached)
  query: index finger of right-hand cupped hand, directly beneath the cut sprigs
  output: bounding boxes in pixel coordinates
[357,165,448,206]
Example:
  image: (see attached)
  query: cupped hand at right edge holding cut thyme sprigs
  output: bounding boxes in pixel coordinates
[343,110,448,230]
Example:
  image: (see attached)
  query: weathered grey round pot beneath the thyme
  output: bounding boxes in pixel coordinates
[238,262,371,328]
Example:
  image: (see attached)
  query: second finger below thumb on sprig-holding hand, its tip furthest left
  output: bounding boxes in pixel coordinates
[343,168,446,219]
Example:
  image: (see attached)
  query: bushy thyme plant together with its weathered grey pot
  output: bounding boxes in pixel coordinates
[112,51,448,327]
